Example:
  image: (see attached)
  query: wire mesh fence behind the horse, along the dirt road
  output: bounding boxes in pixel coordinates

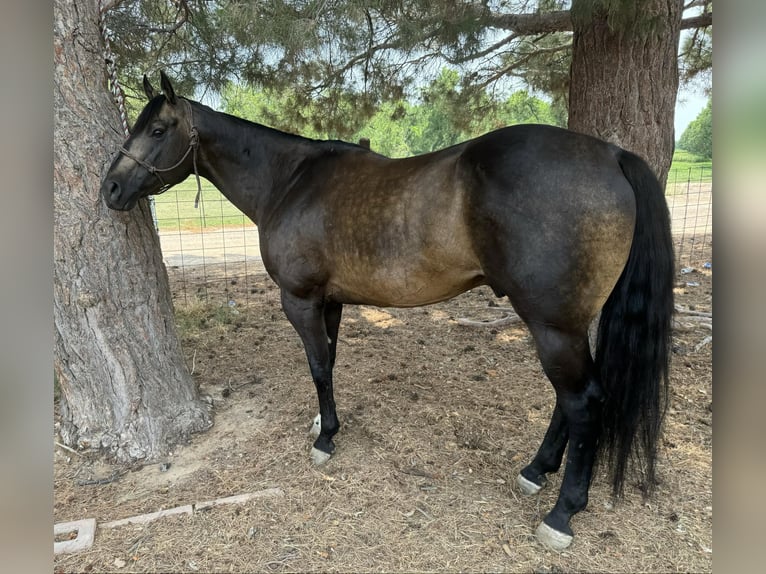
[160,166,713,307]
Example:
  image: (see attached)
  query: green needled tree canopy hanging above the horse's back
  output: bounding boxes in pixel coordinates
[103,0,712,137]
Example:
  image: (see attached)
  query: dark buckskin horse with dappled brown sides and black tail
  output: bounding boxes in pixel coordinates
[100,72,674,551]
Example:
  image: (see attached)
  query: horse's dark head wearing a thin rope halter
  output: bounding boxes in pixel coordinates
[101,72,198,211]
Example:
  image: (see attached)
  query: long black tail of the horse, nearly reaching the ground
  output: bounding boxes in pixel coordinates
[595,150,674,494]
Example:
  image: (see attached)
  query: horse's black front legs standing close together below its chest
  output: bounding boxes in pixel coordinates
[282,290,341,464]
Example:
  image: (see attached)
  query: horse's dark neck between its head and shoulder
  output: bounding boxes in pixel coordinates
[195,107,321,224]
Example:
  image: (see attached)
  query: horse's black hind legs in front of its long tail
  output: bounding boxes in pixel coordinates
[527,323,604,550]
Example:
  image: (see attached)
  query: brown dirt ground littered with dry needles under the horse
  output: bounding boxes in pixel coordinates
[54,244,713,573]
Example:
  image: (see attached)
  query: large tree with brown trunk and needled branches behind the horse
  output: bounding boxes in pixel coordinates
[102,0,712,188]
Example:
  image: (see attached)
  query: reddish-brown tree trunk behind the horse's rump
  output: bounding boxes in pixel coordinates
[569,0,683,187]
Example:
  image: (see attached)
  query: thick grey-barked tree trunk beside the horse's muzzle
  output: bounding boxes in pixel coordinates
[53,0,212,462]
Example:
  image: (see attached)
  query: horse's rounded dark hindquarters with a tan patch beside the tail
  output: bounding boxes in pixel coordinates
[462,126,636,332]
